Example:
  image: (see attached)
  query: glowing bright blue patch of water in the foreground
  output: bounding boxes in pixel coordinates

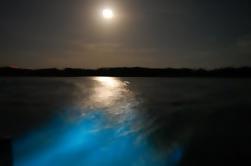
[14,109,182,166]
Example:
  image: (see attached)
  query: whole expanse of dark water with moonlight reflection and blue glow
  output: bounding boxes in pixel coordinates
[0,77,251,166]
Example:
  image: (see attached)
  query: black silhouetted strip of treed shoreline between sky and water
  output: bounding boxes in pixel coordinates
[0,66,251,78]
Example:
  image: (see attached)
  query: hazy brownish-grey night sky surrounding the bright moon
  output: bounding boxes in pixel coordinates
[0,0,251,68]
